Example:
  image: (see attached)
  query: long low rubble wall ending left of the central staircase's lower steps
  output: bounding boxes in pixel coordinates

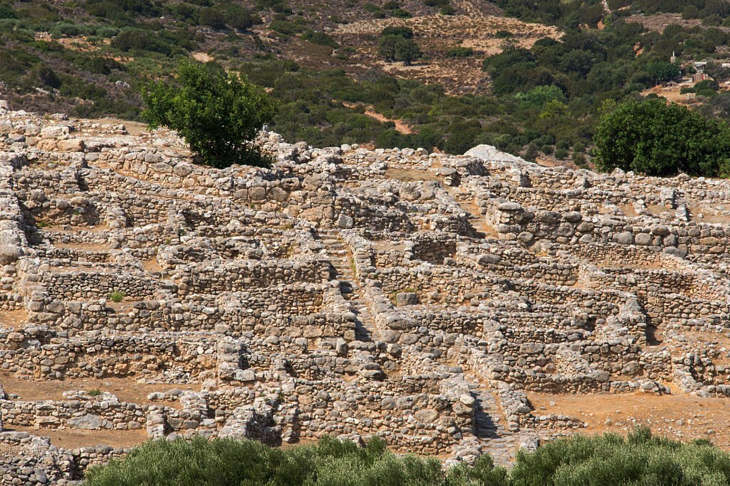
[37,284,354,338]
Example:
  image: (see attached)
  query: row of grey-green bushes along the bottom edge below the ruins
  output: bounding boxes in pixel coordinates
[84,429,730,486]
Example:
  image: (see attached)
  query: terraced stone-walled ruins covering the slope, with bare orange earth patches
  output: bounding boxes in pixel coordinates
[0,106,730,485]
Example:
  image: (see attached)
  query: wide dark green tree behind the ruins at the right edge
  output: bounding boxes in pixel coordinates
[594,99,730,177]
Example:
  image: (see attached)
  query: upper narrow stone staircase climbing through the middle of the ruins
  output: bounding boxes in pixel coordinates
[320,231,378,341]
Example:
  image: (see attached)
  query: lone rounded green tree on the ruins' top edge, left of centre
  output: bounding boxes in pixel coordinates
[142,61,274,168]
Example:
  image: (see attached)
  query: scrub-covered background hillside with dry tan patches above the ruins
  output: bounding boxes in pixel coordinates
[0,0,730,167]
